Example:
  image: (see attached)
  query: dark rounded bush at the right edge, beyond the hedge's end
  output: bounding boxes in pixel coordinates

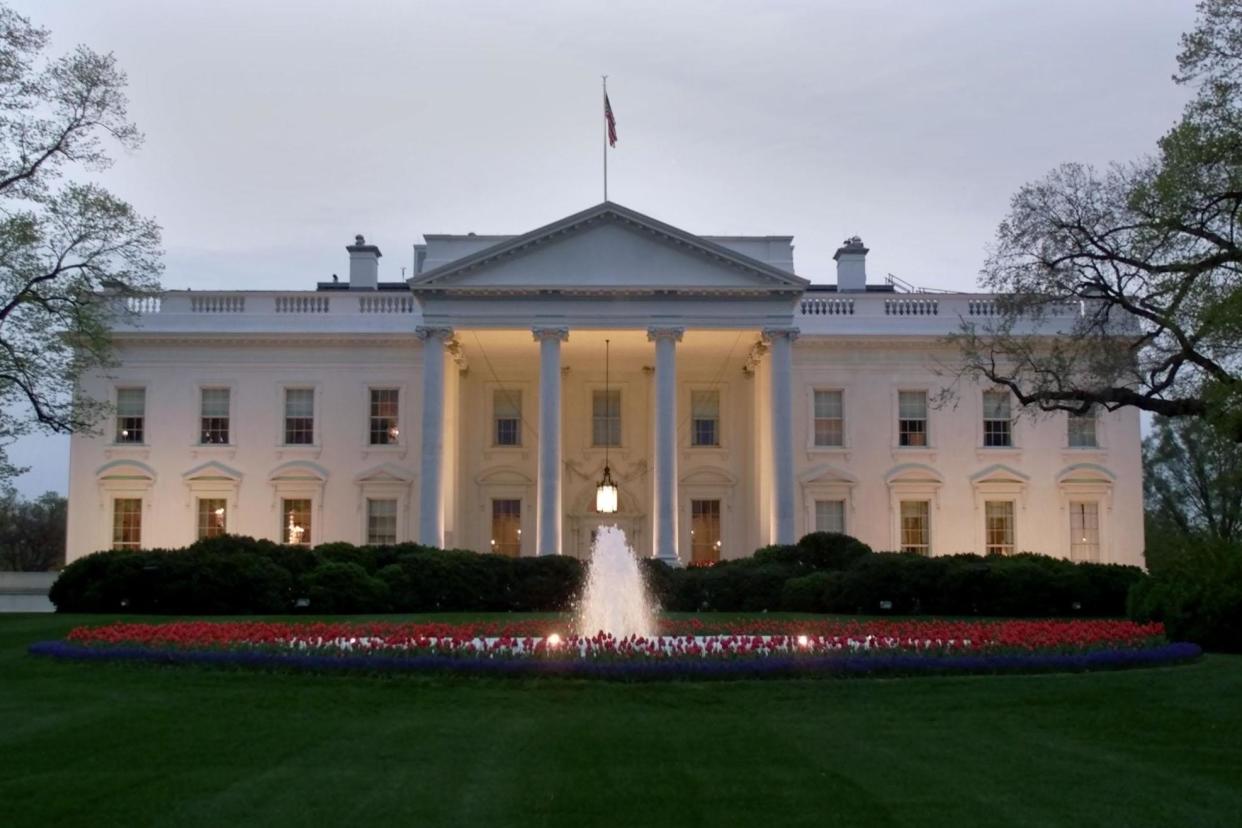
[1129,541,1242,653]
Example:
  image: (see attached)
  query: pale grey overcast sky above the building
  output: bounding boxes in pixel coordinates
[4,0,1194,494]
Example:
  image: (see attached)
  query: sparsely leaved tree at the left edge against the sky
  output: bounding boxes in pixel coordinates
[0,6,160,480]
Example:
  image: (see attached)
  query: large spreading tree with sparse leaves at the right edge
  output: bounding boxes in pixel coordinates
[954,0,1242,442]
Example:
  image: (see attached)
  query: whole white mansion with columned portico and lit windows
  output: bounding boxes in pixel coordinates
[68,202,1144,564]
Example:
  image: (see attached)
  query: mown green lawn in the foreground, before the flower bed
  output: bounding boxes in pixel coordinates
[0,616,1242,828]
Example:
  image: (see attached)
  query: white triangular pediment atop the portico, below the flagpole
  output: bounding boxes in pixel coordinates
[409,201,807,294]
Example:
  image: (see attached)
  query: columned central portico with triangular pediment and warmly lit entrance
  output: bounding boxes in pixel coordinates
[410,204,806,564]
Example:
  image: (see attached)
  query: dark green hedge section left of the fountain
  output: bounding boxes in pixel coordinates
[50,536,584,614]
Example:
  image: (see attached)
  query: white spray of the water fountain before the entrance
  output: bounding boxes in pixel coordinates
[578,526,656,638]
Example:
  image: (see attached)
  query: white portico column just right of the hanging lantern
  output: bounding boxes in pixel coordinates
[647,328,686,566]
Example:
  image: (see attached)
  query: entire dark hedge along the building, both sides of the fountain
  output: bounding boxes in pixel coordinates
[50,533,1142,618]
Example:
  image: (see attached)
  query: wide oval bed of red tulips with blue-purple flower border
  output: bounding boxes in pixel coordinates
[30,619,1200,679]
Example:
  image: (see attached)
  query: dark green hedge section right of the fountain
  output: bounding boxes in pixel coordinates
[647,533,1143,617]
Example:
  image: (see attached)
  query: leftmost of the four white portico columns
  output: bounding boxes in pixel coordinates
[416,328,453,546]
